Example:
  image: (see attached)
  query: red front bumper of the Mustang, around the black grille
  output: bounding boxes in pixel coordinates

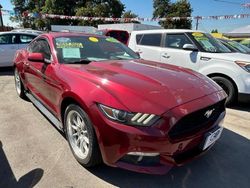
[88,92,225,174]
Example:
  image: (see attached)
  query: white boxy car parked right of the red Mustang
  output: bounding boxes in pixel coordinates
[128,29,250,104]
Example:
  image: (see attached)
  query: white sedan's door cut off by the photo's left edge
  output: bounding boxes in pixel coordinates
[0,33,18,67]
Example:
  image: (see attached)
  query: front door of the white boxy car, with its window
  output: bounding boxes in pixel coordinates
[161,33,200,70]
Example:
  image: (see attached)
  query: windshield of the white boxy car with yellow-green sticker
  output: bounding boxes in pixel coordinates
[192,32,231,53]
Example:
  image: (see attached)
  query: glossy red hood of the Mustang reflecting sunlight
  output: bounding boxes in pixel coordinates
[64,60,221,114]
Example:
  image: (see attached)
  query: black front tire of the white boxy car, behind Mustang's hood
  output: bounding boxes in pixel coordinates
[211,76,237,106]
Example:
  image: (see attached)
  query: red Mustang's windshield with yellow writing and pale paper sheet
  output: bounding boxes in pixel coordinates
[54,36,139,64]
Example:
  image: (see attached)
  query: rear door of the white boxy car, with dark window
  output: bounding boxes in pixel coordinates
[135,33,162,62]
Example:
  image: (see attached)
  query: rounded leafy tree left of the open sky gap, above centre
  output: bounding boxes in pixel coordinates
[76,0,125,27]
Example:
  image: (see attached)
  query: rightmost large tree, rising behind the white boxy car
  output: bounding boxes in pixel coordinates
[153,0,192,29]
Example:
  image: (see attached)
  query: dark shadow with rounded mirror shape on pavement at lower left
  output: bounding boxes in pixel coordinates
[0,141,43,188]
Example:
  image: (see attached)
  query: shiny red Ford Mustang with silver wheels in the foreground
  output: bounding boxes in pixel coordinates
[14,33,229,174]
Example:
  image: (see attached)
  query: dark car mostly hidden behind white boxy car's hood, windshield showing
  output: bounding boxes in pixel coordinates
[217,39,250,54]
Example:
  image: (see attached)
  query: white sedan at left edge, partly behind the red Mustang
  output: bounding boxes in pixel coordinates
[0,31,38,67]
